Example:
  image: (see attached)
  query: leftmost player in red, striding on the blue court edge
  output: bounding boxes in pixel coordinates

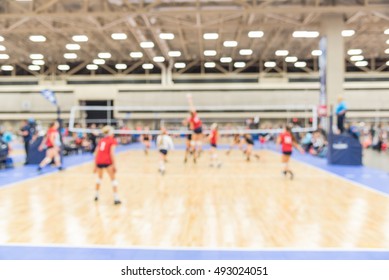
[38,121,62,172]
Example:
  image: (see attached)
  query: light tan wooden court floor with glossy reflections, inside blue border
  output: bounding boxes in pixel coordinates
[0,150,389,249]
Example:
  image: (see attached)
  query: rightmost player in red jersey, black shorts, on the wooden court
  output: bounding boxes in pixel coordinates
[277,126,304,180]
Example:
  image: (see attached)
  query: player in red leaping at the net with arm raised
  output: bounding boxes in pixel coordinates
[187,94,203,163]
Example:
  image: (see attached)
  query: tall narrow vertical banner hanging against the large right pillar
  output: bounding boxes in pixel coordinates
[318,37,327,117]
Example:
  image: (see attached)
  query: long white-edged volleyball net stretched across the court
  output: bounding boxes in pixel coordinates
[69,105,318,135]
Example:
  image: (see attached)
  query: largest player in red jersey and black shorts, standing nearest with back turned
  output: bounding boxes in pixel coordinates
[95,126,121,204]
